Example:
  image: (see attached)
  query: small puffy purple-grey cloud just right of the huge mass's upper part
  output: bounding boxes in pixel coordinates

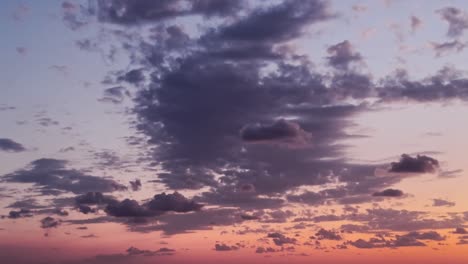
[327,40,362,70]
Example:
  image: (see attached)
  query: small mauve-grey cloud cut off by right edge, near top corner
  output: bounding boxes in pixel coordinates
[437,7,468,38]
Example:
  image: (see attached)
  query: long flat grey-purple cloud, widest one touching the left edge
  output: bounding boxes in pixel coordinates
[2,158,125,194]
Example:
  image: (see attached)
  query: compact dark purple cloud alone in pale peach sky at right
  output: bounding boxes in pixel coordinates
[389,154,439,173]
